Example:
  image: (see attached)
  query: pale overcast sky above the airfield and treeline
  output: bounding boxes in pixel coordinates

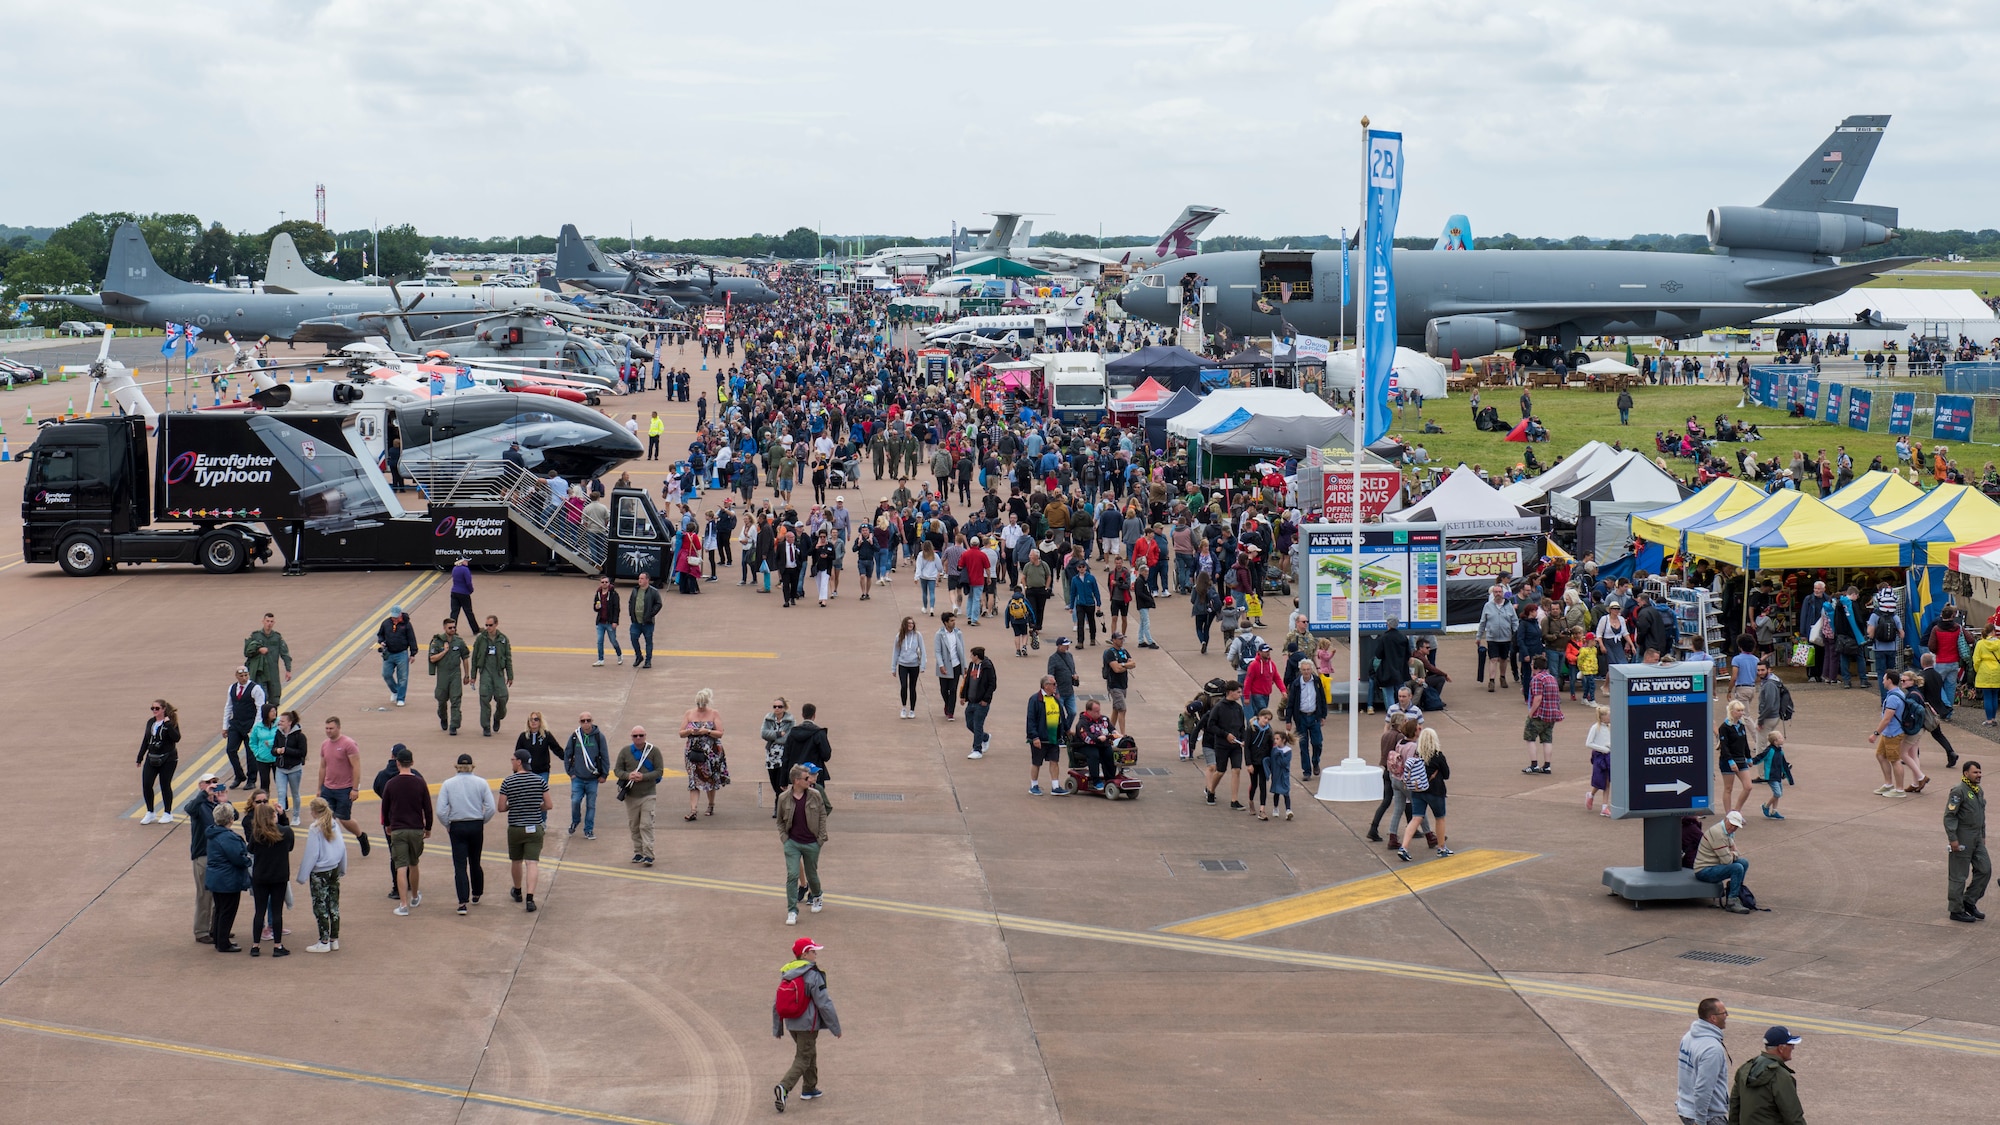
[0,0,2000,236]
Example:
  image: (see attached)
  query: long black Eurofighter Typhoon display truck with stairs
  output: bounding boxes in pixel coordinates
[22,392,672,577]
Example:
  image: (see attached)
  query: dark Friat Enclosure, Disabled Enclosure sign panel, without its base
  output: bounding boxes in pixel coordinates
[1612,661,1716,817]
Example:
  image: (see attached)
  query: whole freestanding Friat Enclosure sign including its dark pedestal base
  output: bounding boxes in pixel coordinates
[1604,661,1718,909]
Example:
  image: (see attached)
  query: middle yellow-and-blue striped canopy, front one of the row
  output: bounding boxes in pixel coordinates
[1688,488,1908,571]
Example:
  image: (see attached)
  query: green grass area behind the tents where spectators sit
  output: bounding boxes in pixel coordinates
[1390,378,2000,478]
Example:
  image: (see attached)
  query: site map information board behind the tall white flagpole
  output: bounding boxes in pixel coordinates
[1300,522,1444,633]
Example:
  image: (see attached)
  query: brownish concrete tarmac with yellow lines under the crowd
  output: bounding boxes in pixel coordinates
[0,344,2000,1123]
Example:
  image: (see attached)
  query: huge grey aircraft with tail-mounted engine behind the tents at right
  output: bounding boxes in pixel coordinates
[1118,116,1922,360]
